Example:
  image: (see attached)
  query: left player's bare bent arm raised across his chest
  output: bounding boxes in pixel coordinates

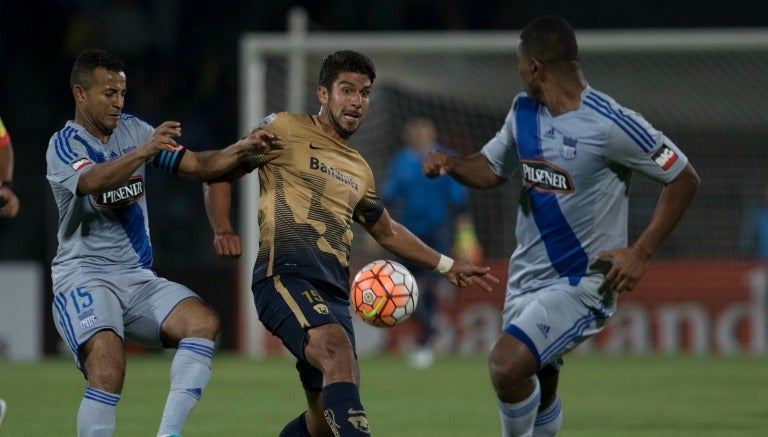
[77,121,181,195]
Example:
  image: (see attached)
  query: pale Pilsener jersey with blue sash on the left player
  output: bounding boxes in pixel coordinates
[46,114,182,282]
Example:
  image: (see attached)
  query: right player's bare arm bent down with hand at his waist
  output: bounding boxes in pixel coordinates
[597,164,700,292]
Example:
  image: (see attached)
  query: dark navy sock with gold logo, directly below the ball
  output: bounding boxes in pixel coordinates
[322,382,371,436]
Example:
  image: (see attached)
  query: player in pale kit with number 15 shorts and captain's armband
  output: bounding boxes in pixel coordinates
[46,49,282,437]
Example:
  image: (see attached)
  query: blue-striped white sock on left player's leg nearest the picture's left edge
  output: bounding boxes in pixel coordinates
[77,387,120,437]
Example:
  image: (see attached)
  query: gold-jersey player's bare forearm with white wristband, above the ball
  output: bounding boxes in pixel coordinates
[362,210,499,291]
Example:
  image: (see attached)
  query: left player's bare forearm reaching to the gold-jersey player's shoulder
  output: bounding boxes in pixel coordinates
[179,129,285,181]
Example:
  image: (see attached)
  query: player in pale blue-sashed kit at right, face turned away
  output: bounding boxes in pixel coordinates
[422,16,699,436]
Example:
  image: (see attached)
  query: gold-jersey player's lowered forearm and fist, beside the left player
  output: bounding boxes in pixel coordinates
[203,169,244,258]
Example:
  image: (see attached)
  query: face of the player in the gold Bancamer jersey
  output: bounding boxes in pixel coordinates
[318,72,372,140]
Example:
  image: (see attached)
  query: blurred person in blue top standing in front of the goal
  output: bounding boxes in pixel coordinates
[382,117,482,368]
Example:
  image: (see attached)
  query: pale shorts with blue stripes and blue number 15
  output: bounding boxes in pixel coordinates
[52,269,199,368]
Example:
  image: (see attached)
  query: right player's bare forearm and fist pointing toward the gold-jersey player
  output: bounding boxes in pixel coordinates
[421,150,507,188]
